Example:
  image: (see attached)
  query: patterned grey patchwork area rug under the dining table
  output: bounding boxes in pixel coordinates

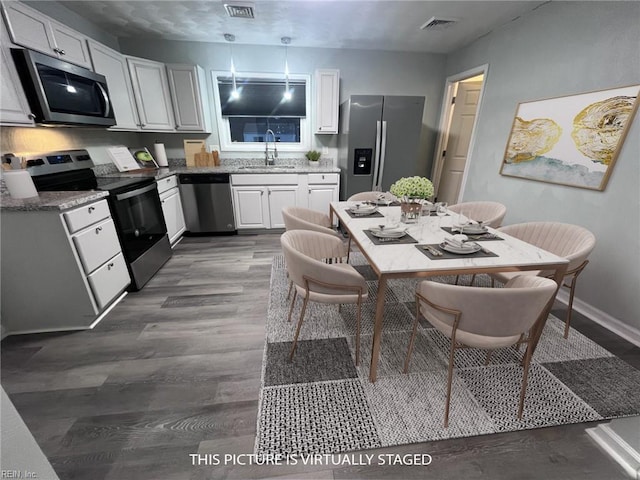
[255,253,640,456]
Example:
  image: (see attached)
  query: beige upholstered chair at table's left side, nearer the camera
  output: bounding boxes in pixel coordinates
[280,230,368,365]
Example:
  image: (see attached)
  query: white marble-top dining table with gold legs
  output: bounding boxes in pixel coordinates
[329,201,568,382]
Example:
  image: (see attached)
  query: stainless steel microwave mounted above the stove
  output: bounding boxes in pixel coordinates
[11,48,116,127]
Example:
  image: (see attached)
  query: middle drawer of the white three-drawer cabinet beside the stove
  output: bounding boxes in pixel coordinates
[73,219,120,273]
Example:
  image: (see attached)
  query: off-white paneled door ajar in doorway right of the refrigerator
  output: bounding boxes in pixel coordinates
[437,81,482,204]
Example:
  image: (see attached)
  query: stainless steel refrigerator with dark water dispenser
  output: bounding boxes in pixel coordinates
[338,95,425,200]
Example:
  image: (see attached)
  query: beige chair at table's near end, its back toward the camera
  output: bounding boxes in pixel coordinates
[404,275,557,428]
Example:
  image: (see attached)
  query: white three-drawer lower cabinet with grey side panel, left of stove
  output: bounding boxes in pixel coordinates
[0,200,131,334]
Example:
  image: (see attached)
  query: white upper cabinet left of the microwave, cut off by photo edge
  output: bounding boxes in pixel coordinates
[0,21,33,126]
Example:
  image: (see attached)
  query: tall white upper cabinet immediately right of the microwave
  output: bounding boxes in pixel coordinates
[89,40,140,130]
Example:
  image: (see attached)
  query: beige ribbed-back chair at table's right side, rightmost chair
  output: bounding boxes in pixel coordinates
[491,222,596,338]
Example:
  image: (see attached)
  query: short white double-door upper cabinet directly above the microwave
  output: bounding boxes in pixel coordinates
[2,2,91,69]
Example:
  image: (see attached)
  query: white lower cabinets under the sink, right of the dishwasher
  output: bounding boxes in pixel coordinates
[231,173,339,230]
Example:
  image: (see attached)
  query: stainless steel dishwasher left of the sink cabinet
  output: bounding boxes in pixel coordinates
[178,173,236,233]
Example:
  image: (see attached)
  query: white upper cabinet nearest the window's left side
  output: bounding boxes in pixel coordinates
[167,64,211,133]
